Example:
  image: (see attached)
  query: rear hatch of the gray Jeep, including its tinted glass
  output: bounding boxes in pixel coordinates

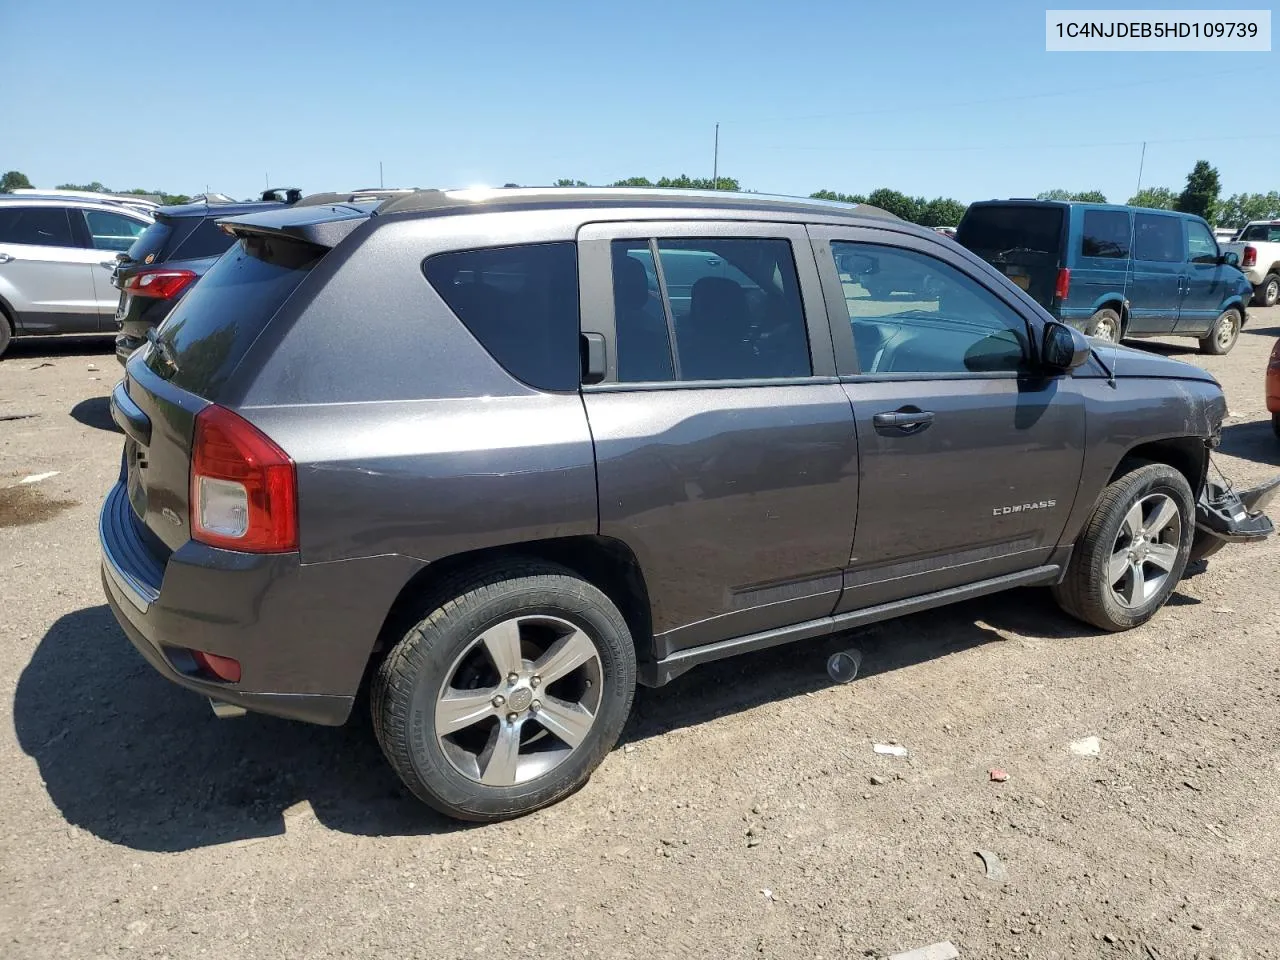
[111,227,328,556]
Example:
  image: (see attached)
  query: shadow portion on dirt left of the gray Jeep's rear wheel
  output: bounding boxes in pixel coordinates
[13,605,458,852]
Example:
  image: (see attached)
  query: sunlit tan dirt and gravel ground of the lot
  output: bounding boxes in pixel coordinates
[0,310,1280,960]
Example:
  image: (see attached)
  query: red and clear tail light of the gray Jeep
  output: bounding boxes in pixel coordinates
[191,404,298,553]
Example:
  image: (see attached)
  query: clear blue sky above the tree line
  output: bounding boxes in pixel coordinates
[0,0,1280,202]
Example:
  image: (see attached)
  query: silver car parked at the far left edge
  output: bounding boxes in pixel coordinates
[0,195,151,355]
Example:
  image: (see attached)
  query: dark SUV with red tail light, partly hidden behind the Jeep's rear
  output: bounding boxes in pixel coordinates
[111,188,301,364]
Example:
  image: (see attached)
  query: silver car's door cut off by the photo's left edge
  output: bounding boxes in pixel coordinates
[0,204,104,333]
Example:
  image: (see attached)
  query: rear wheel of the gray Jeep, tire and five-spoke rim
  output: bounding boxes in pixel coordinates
[371,562,636,822]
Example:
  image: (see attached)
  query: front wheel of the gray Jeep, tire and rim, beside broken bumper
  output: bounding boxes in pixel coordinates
[1053,463,1196,632]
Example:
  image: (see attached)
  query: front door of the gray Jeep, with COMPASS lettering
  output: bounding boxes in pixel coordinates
[813,228,1084,612]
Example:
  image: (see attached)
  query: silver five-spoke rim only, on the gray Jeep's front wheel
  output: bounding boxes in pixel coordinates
[1107,493,1183,608]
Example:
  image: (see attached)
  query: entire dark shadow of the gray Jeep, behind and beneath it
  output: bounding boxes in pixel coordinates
[14,589,1180,852]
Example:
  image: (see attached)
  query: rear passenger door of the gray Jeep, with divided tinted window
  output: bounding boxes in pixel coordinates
[579,221,858,657]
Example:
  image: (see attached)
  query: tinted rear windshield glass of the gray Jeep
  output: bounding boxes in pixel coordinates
[147,237,326,399]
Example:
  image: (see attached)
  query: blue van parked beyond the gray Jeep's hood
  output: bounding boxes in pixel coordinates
[956,200,1253,353]
